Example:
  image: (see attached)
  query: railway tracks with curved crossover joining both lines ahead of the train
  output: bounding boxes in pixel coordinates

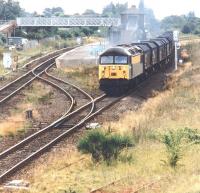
[0,46,133,183]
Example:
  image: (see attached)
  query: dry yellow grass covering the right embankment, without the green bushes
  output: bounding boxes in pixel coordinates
[6,42,200,193]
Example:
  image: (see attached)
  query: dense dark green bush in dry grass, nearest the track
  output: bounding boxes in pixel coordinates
[78,130,134,164]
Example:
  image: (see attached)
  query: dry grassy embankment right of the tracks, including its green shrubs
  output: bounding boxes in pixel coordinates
[10,44,200,193]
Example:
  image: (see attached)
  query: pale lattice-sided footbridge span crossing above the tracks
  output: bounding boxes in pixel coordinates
[17,17,121,27]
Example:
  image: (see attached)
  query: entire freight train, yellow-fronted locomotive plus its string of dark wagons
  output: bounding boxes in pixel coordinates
[99,32,174,94]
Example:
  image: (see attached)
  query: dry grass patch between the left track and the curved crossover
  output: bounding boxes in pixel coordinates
[0,82,53,137]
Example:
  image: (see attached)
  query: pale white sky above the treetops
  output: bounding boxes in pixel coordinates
[18,0,200,19]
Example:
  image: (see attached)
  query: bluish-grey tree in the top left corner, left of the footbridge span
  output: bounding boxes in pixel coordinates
[0,0,23,20]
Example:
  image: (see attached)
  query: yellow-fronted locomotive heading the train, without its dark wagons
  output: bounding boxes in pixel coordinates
[99,46,143,92]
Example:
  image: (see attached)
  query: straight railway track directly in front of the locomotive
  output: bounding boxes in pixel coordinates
[0,89,123,183]
